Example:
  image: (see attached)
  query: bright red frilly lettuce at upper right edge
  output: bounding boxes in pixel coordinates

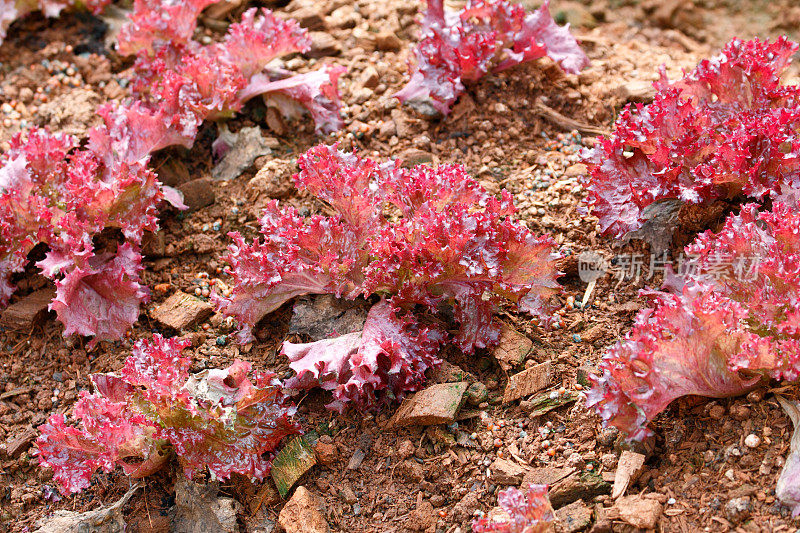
[585,37,800,237]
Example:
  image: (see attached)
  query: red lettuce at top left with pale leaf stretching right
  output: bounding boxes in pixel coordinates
[124,7,344,137]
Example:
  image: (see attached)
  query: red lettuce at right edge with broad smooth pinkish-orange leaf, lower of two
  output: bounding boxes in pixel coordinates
[587,203,800,439]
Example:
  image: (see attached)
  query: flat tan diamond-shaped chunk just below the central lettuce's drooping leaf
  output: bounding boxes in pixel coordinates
[388,381,468,427]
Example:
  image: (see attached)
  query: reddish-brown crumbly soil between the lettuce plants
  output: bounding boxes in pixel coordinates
[0,0,800,533]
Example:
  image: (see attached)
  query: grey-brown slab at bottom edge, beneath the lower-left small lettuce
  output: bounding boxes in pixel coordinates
[170,479,241,533]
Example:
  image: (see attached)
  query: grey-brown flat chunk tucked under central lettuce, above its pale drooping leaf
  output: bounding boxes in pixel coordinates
[289,294,367,341]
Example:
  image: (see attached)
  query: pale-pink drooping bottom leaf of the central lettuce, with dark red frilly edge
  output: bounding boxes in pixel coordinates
[281,300,446,412]
